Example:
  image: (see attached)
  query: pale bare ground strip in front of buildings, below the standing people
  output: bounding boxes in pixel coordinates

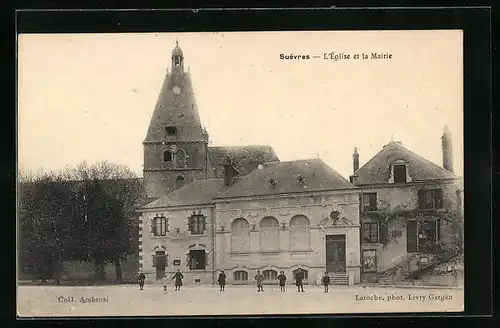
[17,285,464,317]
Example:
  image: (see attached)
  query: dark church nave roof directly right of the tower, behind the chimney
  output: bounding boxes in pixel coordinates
[208,145,279,178]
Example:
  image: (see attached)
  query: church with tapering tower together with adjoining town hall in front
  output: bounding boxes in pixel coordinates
[138,44,361,285]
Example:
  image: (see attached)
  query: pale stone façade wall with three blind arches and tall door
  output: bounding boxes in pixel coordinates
[215,192,360,283]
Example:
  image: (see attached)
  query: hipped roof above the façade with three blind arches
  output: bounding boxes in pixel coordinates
[218,159,355,198]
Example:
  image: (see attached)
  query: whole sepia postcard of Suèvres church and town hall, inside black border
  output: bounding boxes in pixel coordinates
[16,30,465,317]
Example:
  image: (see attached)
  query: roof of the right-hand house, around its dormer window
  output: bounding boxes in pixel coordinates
[352,141,457,186]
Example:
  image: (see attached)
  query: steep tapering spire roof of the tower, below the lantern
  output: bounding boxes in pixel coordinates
[144,72,205,142]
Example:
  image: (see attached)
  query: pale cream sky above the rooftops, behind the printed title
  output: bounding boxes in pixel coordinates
[18,30,463,178]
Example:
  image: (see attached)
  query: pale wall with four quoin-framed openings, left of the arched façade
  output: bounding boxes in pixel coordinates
[140,206,214,285]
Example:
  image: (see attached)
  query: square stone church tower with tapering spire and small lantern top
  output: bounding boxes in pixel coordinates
[143,42,208,198]
